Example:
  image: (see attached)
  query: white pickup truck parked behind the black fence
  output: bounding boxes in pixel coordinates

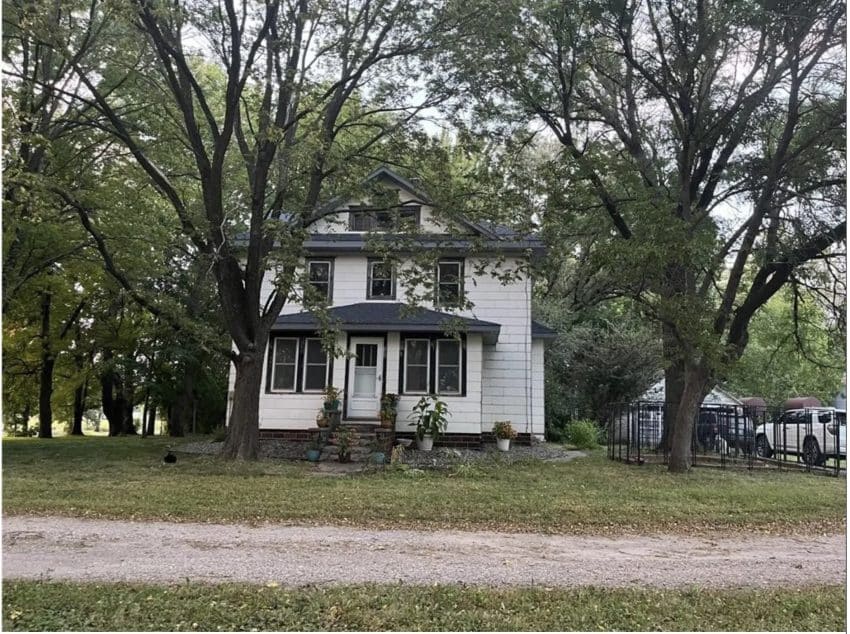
[755,407,847,466]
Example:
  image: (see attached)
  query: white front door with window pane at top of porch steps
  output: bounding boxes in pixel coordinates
[346,337,384,419]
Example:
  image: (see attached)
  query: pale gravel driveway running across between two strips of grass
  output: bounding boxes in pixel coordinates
[3,516,846,587]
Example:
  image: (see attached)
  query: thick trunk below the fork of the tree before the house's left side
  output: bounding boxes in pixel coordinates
[222,346,265,460]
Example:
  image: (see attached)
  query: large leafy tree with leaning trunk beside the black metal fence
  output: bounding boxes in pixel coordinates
[446,0,846,472]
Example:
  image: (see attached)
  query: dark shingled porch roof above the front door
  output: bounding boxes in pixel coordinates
[272,302,501,343]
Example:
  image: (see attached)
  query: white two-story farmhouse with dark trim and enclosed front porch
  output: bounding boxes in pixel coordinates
[230,167,554,445]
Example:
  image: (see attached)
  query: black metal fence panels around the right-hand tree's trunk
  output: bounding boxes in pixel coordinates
[607,401,847,475]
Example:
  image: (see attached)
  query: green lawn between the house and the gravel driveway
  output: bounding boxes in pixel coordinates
[3,438,846,533]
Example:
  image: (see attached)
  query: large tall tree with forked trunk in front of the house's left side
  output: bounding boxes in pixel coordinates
[8,0,458,459]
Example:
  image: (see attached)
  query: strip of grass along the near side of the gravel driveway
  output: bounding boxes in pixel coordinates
[3,581,846,632]
